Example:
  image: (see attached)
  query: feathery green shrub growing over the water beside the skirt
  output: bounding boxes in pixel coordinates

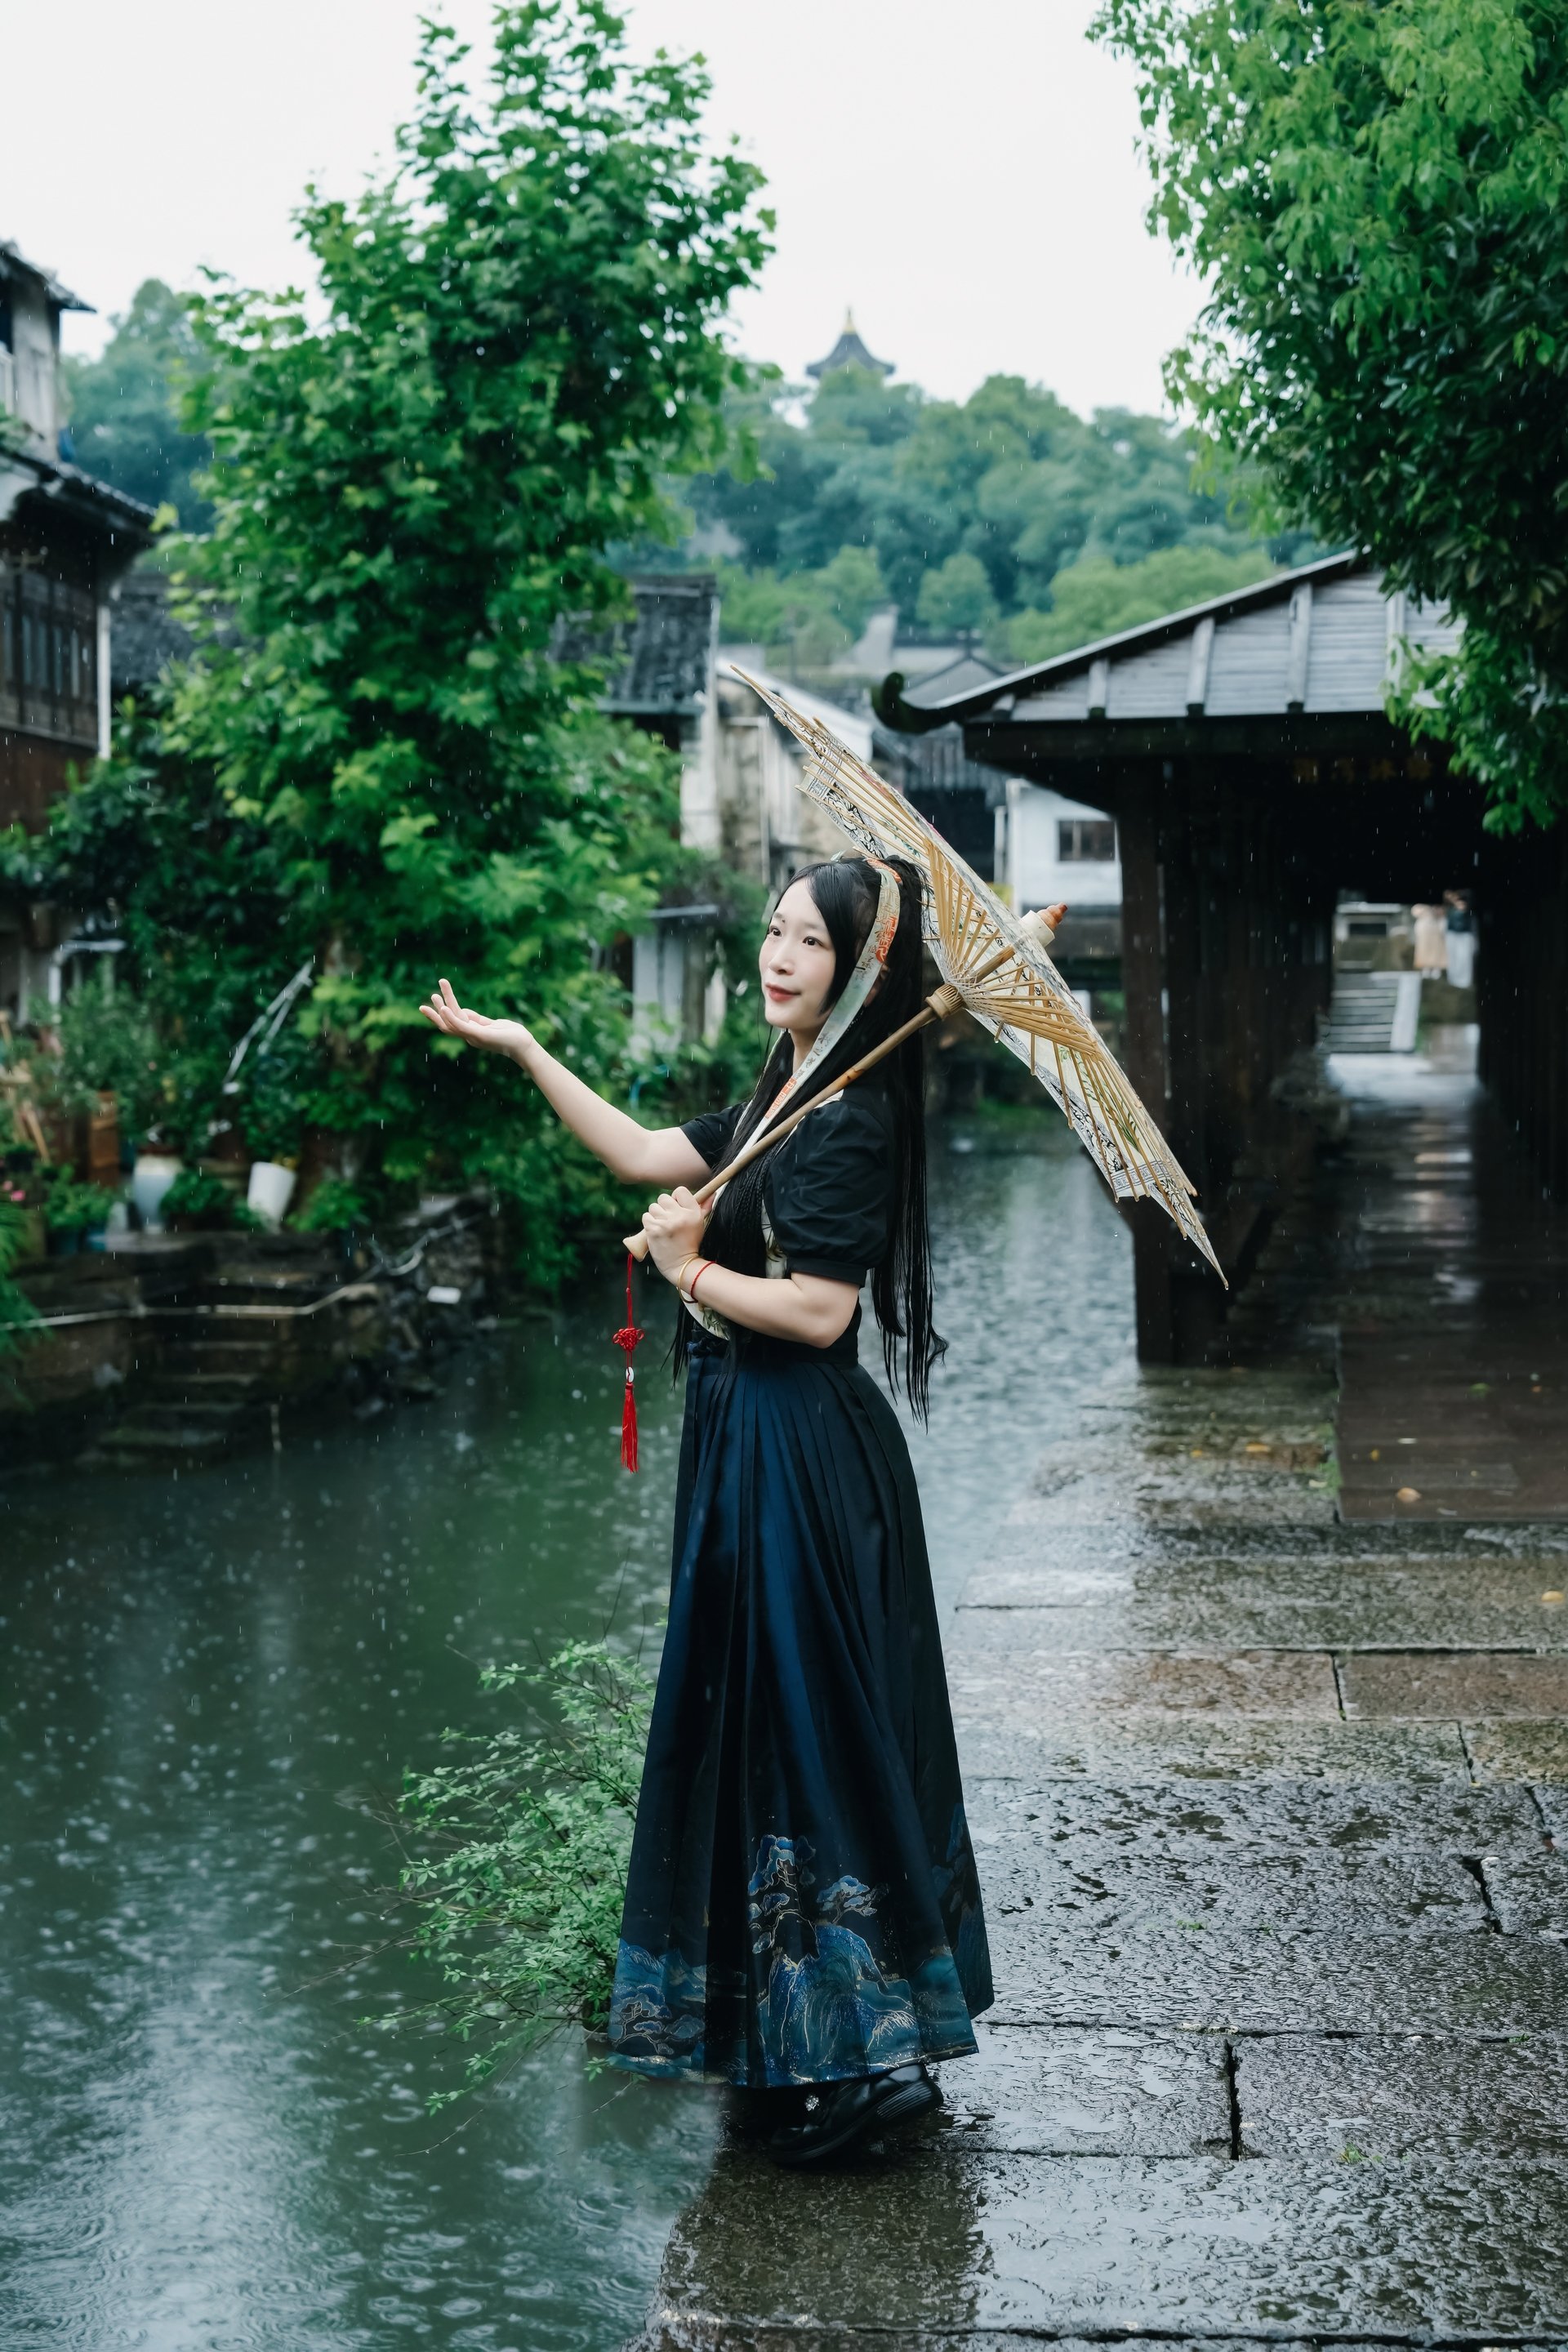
[381,1642,653,2107]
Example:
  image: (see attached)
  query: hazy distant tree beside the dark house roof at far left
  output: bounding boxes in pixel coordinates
[64,278,212,532]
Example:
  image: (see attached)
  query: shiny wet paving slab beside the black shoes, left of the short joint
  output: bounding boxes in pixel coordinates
[940,2023,1229,2157]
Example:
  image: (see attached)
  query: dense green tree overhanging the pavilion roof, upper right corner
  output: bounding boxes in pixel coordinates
[1098,0,1568,831]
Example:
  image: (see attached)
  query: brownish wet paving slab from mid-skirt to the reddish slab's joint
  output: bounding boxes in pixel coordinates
[947,1637,1340,1724]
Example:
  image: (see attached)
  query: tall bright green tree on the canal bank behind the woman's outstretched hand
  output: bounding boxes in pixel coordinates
[12,0,766,1277]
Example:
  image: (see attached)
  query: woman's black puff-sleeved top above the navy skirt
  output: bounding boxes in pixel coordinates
[682,1085,893,1289]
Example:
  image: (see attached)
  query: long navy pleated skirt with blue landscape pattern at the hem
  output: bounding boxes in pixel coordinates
[609,1334,992,2088]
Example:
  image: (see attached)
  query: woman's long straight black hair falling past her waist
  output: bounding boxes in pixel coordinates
[677,858,947,1421]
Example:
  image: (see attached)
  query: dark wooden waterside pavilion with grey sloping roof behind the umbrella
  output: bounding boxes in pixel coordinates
[880,555,1486,1362]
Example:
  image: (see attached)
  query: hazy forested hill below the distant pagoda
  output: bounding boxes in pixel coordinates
[682,367,1303,663]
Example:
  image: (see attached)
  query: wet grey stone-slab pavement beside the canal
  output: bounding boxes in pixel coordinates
[647,1054,1568,2352]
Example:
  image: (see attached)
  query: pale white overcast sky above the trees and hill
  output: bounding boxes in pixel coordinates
[0,0,1196,409]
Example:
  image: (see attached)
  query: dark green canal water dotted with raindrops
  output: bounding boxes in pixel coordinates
[0,1117,1133,2352]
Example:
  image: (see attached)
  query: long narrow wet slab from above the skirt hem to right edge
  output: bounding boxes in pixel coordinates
[987,1912,1568,2034]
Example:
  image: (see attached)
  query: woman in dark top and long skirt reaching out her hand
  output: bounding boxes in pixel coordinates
[423,858,992,2164]
